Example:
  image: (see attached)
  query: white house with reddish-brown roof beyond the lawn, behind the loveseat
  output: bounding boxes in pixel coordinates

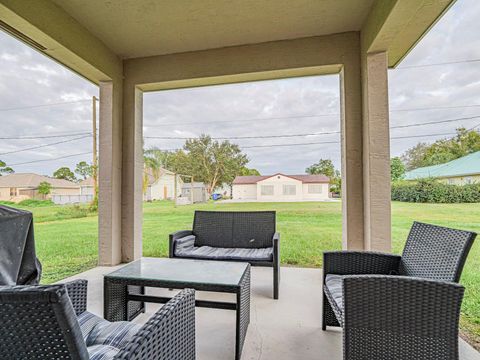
[232,173,330,201]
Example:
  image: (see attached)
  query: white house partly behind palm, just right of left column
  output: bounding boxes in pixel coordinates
[144,168,183,201]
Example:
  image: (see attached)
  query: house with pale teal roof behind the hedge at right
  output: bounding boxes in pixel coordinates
[405,151,480,185]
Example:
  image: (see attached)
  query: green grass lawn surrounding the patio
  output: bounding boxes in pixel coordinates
[11,202,480,346]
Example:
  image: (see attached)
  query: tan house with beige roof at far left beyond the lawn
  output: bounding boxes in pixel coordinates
[0,173,80,201]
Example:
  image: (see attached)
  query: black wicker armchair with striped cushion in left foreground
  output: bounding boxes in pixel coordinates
[0,280,195,360]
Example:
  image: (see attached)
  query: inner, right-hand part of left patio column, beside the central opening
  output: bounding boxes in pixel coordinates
[122,85,143,262]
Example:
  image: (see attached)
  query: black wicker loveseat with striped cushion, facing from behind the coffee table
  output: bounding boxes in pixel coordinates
[170,211,280,299]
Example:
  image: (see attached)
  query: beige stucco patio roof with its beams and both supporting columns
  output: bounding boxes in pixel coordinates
[0,0,454,265]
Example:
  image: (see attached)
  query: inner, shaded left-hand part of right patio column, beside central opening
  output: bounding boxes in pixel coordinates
[340,57,364,250]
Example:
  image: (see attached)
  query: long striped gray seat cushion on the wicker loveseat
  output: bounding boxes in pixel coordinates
[175,246,273,261]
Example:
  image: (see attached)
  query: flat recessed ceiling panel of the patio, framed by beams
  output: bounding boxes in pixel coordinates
[53,0,374,58]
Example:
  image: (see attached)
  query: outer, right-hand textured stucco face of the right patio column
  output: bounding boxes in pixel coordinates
[362,52,391,252]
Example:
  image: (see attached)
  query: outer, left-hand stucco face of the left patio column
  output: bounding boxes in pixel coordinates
[98,81,123,265]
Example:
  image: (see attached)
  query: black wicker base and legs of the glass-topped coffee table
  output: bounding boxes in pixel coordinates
[104,259,250,360]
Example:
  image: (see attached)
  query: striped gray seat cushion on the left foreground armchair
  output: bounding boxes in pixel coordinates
[78,311,141,360]
